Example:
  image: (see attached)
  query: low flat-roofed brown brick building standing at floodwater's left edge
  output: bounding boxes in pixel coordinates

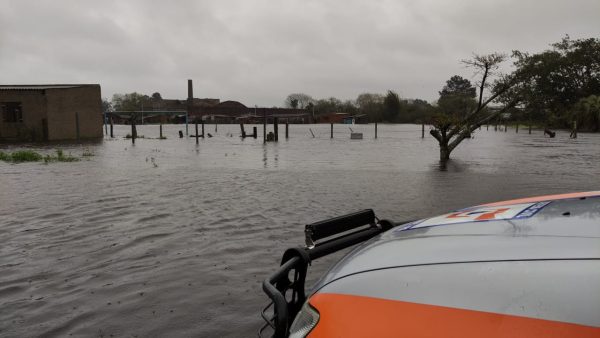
[0,84,102,141]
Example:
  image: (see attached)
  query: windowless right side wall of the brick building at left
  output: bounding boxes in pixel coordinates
[46,85,103,141]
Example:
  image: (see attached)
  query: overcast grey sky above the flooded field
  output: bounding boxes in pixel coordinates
[0,0,600,106]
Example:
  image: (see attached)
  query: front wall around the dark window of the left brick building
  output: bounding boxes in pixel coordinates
[0,90,47,140]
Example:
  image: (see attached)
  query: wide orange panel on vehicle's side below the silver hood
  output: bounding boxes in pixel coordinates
[309,293,600,338]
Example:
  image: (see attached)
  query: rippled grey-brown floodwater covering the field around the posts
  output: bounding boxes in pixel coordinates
[0,125,600,337]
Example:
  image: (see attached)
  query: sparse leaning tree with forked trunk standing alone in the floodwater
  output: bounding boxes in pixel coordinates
[429,53,519,161]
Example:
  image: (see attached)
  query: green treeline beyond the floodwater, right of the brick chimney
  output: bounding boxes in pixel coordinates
[285,36,600,131]
